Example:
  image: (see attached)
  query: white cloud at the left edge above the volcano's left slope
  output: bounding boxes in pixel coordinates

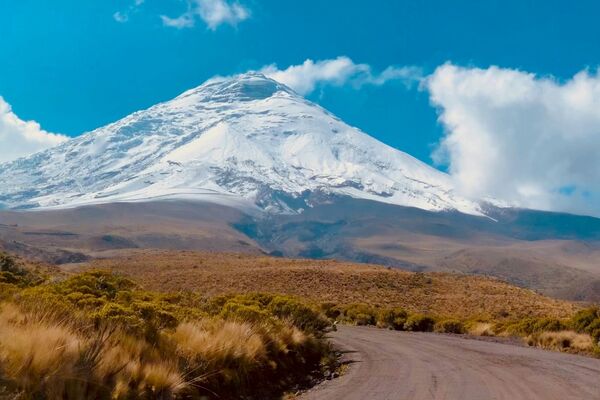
[0,97,67,162]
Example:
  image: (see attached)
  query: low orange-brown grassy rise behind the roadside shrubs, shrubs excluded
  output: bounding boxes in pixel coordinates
[79,251,578,319]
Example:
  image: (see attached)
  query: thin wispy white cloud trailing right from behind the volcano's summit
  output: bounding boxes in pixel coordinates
[260,56,421,95]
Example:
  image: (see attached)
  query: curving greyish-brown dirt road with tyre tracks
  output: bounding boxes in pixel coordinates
[301,326,600,400]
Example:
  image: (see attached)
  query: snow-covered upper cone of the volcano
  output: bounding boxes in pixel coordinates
[0,73,481,214]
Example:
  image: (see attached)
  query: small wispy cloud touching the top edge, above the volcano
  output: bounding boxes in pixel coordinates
[161,0,250,30]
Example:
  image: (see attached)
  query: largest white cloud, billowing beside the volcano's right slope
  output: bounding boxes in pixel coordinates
[423,64,600,215]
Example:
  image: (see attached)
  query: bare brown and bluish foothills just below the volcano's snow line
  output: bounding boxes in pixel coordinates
[0,199,600,301]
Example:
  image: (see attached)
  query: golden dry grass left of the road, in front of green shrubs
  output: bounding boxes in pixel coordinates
[0,290,333,400]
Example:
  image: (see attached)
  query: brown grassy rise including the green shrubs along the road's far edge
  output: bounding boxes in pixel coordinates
[84,251,600,353]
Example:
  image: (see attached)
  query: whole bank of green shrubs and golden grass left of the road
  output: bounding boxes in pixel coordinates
[0,255,337,399]
